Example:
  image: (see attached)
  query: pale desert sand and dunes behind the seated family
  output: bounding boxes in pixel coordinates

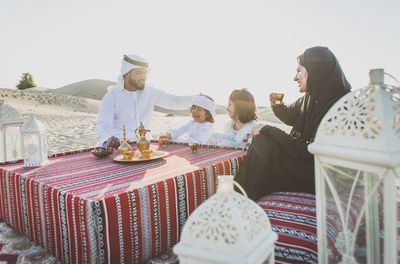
[0,80,290,154]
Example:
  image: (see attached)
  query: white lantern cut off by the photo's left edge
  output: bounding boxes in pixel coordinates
[0,100,24,162]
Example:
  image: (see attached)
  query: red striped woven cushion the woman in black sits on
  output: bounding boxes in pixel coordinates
[257,192,318,263]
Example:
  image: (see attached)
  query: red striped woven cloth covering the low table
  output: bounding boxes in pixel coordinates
[0,142,246,263]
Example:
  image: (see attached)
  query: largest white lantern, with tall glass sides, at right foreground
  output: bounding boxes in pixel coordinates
[308,69,400,264]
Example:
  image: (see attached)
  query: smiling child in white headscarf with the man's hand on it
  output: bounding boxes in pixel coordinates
[160,95,215,144]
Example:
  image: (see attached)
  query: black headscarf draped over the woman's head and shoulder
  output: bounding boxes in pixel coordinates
[293,47,351,141]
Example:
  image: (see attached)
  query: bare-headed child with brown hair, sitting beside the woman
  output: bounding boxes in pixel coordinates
[207,88,257,148]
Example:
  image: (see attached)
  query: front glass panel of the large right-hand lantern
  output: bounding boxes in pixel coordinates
[321,163,384,263]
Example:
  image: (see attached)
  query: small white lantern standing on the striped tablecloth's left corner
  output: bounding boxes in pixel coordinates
[21,115,48,167]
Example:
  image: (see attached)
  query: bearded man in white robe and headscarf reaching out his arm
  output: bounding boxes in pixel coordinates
[96,55,193,148]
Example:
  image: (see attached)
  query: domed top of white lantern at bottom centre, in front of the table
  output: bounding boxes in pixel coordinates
[174,176,278,264]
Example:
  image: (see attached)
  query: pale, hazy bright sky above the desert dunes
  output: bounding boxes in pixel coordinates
[0,0,400,106]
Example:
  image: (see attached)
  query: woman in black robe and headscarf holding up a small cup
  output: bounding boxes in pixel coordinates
[236,47,351,200]
